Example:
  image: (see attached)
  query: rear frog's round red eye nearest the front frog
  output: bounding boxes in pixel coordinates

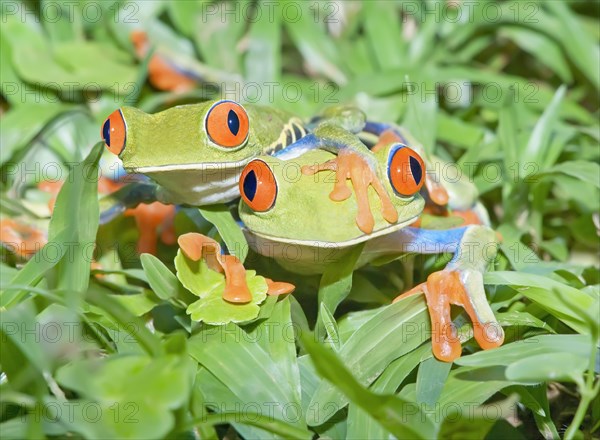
[205,101,249,148]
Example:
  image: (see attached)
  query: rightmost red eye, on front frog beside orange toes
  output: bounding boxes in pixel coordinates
[388,144,425,196]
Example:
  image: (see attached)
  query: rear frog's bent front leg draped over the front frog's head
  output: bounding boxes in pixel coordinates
[276,124,398,234]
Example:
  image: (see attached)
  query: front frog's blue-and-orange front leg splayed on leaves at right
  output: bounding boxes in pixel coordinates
[394,225,504,362]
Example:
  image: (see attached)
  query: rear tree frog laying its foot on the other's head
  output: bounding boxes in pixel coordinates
[102,100,397,233]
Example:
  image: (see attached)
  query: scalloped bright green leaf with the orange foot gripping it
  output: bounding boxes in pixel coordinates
[175,232,294,325]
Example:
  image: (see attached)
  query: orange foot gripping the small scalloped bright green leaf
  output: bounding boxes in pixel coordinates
[177,232,294,303]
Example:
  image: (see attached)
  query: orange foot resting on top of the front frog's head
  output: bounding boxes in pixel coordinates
[302,149,398,234]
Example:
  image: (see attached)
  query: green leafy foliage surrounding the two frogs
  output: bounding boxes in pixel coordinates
[0,0,600,438]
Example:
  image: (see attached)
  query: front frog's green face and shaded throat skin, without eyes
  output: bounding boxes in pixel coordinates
[239,145,425,274]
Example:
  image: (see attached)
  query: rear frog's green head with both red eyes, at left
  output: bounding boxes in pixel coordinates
[102,100,261,173]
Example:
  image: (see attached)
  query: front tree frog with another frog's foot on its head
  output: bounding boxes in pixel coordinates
[239,146,504,361]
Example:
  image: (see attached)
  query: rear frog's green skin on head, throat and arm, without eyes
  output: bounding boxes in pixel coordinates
[113,100,375,206]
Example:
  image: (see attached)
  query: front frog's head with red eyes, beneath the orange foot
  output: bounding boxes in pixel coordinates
[239,143,425,247]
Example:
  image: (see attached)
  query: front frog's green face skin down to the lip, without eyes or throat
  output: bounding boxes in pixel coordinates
[239,145,425,245]
